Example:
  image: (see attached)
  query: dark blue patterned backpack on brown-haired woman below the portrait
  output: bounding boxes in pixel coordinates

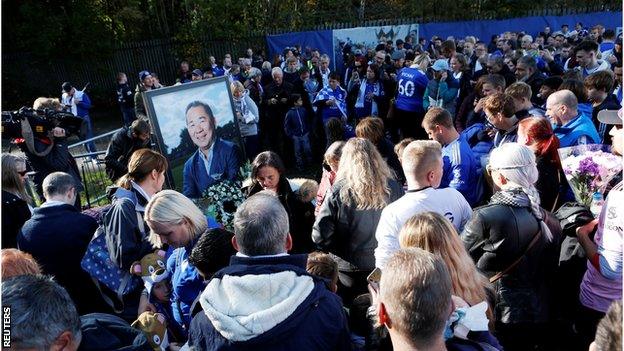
[80,205,145,313]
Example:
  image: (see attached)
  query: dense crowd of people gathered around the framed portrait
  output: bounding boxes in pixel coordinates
[2,23,624,350]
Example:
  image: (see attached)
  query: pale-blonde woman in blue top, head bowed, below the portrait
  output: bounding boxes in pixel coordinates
[145,190,219,330]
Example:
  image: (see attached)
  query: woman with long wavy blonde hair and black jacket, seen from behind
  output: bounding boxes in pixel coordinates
[312,138,403,300]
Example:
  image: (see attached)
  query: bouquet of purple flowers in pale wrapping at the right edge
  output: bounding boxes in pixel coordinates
[559,144,622,207]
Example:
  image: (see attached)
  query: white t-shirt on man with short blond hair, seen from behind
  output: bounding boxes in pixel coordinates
[375,188,472,269]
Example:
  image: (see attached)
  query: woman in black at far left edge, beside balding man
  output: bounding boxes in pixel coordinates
[2,153,32,249]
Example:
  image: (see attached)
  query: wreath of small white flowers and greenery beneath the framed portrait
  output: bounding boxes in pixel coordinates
[194,161,251,231]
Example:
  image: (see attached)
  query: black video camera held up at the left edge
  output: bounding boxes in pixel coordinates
[2,107,84,140]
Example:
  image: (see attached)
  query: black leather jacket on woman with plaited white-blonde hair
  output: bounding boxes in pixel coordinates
[461,204,554,324]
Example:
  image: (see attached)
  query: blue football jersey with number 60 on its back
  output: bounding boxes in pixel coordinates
[395,67,429,113]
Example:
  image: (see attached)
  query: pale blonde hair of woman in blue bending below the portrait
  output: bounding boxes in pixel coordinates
[144,190,208,247]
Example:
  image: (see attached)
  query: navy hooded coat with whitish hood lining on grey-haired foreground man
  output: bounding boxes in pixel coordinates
[188,255,351,351]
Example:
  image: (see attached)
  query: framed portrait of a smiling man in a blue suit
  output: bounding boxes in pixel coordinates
[144,77,245,198]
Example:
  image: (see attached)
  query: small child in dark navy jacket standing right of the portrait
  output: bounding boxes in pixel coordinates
[284,94,312,170]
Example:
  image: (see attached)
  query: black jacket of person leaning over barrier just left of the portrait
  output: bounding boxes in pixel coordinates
[104,127,149,182]
